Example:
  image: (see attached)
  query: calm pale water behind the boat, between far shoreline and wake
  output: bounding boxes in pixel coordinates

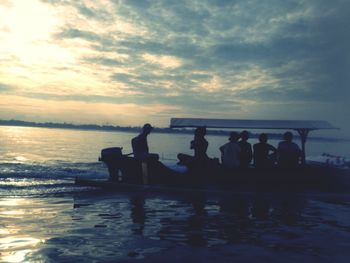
[0,126,350,164]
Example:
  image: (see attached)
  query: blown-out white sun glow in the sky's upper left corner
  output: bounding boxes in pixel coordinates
[0,0,71,66]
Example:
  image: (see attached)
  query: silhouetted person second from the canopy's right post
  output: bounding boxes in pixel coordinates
[253,133,277,169]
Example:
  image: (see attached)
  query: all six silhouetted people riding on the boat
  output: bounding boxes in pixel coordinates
[132,123,302,174]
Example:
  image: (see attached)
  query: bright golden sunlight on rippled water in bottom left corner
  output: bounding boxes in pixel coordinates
[0,197,70,262]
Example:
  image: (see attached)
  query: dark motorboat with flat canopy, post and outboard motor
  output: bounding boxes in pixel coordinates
[75,118,350,195]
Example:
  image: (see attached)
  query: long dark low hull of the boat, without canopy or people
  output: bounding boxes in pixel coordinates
[76,161,350,193]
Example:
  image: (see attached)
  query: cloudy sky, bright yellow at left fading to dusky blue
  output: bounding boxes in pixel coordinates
[0,0,350,134]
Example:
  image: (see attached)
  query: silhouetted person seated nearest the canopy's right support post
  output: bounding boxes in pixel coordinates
[277,132,301,168]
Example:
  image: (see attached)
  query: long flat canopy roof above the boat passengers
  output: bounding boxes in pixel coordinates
[170,118,337,130]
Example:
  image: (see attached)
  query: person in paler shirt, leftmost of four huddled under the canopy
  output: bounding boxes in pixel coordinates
[219,132,241,170]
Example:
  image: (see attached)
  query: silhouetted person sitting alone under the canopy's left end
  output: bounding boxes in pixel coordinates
[177,127,209,168]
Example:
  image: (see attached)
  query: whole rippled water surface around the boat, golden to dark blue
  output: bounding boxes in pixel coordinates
[0,126,350,263]
